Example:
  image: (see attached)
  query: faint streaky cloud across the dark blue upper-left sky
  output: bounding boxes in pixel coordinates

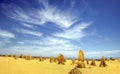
[2,4,44,25]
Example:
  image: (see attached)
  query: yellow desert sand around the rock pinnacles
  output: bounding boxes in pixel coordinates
[0,57,120,74]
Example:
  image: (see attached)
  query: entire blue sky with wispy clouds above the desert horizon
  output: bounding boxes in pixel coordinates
[0,0,120,58]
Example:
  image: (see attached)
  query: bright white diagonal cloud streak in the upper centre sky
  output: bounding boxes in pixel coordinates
[38,1,78,28]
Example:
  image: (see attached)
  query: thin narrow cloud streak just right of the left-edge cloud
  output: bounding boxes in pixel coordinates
[17,29,42,37]
